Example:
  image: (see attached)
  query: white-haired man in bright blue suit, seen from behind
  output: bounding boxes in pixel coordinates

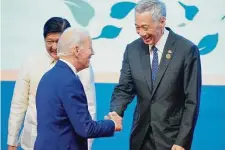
[34,28,122,150]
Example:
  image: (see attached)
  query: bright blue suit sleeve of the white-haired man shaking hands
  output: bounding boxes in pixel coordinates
[60,79,115,138]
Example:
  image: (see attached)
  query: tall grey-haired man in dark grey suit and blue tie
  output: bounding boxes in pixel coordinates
[110,0,201,150]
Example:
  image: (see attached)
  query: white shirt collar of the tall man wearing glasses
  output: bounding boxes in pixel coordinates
[149,29,169,53]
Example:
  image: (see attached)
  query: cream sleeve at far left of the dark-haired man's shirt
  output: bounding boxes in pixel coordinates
[7,59,30,146]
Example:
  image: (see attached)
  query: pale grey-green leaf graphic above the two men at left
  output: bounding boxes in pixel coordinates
[65,0,95,27]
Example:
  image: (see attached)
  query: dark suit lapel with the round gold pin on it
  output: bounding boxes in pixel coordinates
[152,28,176,96]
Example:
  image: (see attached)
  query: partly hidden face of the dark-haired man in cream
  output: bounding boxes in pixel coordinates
[45,33,61,59]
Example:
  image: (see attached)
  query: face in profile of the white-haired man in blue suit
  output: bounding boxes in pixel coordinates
[78,37,94,69]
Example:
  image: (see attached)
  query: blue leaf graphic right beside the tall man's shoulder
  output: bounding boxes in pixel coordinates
[198,33,218,55]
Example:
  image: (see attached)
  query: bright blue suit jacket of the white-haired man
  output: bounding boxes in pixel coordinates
[34,60,115,150]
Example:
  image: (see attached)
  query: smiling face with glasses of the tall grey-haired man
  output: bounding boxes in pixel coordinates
[135,11,166,45]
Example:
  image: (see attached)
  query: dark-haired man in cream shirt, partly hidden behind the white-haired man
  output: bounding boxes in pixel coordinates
[7,17,96,150]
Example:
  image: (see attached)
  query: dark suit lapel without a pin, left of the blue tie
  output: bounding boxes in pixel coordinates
[139,40,152,93]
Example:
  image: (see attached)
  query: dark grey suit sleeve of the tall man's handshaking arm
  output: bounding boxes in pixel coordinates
[110,45,136,117]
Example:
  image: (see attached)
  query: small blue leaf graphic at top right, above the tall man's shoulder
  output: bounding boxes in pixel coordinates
[179,1,199,20]
